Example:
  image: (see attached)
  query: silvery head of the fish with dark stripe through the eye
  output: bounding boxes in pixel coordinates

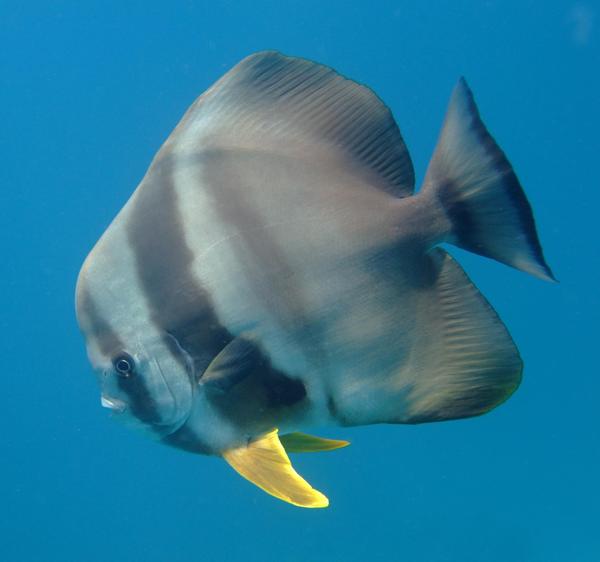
[76,246,195,439]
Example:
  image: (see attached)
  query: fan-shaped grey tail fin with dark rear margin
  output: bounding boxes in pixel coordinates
[424,78,555,280]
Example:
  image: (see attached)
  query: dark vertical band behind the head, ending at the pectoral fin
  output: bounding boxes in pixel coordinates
[127,159,232,377]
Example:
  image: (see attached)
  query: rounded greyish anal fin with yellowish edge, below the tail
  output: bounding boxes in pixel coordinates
[402,248,523,423]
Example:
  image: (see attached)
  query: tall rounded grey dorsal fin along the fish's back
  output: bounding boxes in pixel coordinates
[165,51,414,197]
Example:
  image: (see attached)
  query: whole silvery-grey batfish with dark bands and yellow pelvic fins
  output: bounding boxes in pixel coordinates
[75,51,555,508]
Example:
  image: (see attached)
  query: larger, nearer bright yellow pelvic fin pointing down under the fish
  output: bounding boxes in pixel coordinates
[223,429,329,507]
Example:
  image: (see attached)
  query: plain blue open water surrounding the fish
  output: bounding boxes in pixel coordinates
[0,0,600,562]
